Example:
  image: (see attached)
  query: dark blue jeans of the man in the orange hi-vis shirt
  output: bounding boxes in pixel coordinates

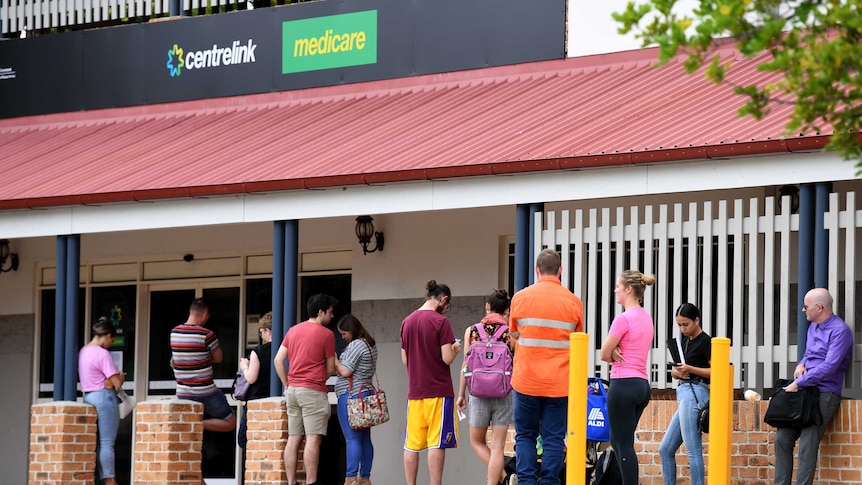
[512,391,569,485]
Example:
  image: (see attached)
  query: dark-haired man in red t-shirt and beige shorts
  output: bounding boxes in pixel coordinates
[274,294,338,485]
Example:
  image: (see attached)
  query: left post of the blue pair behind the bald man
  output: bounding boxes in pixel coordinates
[796,184,816,362]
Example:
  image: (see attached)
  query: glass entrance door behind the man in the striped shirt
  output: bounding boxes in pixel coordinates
[147,283,240,483]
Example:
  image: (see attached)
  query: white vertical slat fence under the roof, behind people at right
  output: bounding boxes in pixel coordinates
[533,193,862,394]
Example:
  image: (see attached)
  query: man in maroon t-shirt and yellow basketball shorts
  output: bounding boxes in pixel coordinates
[401,280,461,485]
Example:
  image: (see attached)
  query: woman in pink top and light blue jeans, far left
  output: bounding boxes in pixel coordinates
[78,317,123,485]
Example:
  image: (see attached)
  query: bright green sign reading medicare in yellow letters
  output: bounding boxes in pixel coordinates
[281,10,377,74]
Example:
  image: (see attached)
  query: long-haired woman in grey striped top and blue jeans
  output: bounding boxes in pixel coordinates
[335,314,377,485]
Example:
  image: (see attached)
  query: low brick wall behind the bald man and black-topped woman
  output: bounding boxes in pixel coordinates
[635,400,862,485]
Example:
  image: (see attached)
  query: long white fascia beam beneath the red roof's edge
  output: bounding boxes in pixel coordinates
[0,152,855,238]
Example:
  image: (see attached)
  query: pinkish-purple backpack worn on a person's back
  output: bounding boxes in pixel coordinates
[464,323,512,398]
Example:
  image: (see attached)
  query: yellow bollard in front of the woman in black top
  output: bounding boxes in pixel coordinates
[708,337,733,485]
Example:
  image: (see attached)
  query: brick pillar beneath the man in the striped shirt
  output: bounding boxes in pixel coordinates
[134,398,204,485]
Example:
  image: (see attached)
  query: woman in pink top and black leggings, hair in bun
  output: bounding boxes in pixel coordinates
[601,269,655,485]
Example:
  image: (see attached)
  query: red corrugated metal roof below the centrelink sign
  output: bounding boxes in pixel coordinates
[0,45,826,209]
